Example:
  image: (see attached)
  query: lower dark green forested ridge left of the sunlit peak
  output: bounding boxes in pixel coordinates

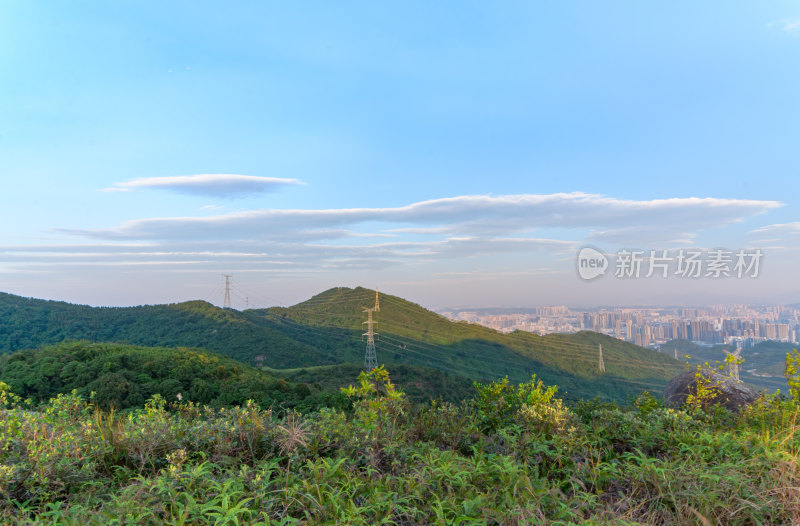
[0,293,318,366]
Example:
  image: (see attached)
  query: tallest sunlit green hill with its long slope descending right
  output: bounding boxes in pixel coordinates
[260,287,682,400]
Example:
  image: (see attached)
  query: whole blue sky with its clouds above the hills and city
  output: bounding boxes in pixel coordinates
[0,0,800,307]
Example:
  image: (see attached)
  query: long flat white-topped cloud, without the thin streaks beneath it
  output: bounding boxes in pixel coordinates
[61,193,782,241]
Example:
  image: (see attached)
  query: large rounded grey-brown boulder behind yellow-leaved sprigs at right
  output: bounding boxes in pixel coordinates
[664,369,758,411]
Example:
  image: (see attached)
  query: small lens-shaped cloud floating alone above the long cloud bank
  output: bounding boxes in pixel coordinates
[101,174,304,198]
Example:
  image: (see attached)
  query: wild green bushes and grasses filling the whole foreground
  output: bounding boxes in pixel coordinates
[0,368,800,525]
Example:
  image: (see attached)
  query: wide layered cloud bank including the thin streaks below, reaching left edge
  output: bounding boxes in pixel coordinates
[0,193,780,288]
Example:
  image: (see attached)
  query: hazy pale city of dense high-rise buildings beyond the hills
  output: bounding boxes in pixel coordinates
[441,305,800,348]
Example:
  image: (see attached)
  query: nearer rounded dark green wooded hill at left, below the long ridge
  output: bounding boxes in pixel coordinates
[0,342,341,410]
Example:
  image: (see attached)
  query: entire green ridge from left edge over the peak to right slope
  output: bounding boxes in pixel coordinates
[0,287,682,400]
